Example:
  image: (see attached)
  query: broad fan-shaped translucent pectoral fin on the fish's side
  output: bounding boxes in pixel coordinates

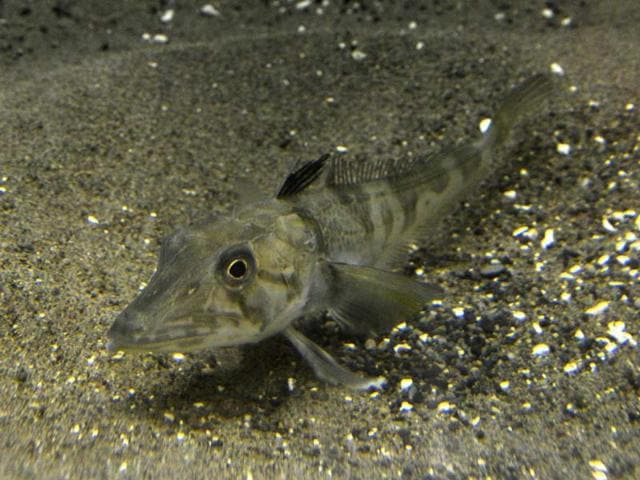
[327,263,444,334]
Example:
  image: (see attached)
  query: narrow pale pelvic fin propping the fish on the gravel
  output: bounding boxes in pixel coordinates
[284,327,386,390]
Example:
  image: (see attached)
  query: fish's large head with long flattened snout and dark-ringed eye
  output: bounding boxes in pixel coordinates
[108,201,318,352]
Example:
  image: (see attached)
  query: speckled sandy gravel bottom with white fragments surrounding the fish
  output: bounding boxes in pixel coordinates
[0,1,640,479]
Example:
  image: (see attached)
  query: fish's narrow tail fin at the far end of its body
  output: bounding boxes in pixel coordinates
[480,74,554,150]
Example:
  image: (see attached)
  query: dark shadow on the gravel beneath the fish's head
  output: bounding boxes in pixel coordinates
[125,337,313,430]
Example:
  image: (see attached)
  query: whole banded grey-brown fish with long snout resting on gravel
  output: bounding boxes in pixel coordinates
[108,75,552,389]
